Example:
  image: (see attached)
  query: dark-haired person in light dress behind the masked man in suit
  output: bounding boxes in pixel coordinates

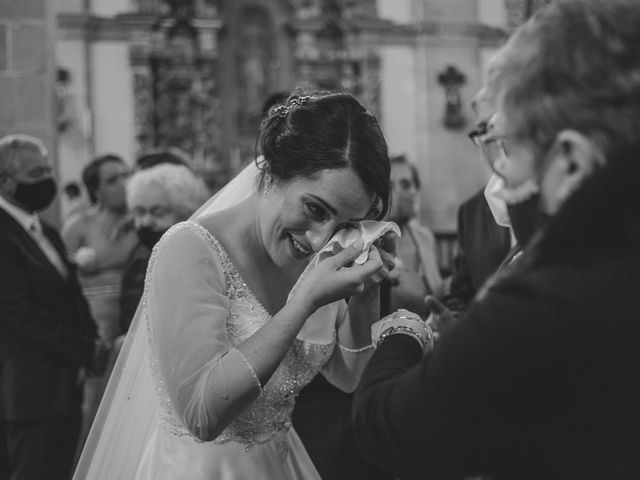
[62,155,137,454]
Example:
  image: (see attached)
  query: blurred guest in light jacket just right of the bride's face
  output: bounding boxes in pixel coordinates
[387,155,445,316]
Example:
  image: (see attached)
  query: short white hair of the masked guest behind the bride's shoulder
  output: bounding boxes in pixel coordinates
[127,163,209,220]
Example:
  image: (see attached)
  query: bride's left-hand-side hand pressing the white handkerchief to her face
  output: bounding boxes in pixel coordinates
[292,240,386,311]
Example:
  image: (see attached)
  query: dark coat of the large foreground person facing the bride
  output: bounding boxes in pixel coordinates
[353,151,640,480]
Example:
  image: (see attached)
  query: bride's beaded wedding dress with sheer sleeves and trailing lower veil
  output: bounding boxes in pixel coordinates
[74,163,371,480]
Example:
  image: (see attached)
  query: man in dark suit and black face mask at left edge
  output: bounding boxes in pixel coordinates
[0,135,108,480]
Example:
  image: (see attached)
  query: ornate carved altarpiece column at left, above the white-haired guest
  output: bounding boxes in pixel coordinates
[121,0,227,190]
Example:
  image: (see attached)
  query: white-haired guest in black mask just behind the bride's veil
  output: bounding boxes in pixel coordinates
[120,159,208,331]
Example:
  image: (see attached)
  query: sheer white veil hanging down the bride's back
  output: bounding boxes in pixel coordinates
[73,162,259,480]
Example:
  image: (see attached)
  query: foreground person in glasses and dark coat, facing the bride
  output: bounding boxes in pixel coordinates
[353,0,640,479]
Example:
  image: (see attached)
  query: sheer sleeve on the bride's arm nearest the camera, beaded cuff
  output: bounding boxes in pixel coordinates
[147,224,261,441]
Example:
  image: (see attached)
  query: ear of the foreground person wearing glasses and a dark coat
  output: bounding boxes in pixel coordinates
[541,130,604,214]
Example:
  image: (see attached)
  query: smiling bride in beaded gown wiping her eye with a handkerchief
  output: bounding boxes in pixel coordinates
[74,93,392,480]
